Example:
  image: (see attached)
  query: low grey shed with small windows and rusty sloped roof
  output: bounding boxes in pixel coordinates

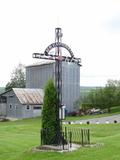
[0,88,44,119]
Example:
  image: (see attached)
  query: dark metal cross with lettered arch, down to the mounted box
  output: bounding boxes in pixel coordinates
[33,28,81,124]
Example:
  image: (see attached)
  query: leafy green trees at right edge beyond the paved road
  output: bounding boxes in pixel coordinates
[82,80,120,112]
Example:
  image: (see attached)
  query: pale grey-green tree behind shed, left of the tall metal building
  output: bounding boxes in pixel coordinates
[5,64,26,91]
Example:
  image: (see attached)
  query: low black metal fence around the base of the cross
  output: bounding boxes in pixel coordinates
[40,127,90,150]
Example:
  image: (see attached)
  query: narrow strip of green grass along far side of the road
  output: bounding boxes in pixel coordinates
[65,106,120,121]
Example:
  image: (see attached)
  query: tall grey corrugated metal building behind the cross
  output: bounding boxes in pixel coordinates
[26,61,80,112]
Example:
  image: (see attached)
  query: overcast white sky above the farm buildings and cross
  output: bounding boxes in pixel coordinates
[0,0,120,86]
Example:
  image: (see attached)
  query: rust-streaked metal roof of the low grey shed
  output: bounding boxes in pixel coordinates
[13,88,44,104]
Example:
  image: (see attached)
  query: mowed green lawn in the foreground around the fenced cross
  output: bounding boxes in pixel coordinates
[0,118,120,160]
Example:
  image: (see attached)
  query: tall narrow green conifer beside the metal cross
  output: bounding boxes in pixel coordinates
[42,80,60,144]
